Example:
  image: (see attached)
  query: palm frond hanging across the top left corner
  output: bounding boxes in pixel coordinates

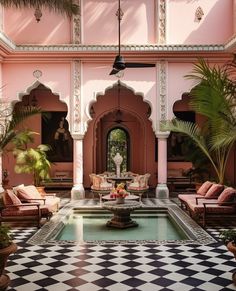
[0,0,79,17]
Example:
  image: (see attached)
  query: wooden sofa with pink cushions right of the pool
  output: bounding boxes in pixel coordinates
[178,181,236,227]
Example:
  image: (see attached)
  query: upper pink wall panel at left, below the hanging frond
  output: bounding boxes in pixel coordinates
[4,9,71,45]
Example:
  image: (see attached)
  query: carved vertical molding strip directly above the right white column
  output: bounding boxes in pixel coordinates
[158,61,167,121]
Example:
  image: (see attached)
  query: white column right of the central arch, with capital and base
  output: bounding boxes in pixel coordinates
[156,132,170,199]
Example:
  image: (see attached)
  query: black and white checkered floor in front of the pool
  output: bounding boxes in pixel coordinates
[6,197,236,291]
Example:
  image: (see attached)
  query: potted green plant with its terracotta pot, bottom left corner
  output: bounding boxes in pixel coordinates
[0,225,17,290]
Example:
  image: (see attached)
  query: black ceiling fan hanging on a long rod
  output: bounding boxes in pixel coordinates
[110,0,155,75]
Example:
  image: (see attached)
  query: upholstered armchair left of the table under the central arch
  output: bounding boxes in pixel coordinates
[89,174,114,202]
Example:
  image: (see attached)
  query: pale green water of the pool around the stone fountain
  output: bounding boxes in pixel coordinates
[54,211,189,242]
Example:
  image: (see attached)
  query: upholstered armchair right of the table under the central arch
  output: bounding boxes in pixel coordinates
[127,173,150,201]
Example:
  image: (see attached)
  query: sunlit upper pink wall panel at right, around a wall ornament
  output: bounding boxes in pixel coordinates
[167,0,233,44]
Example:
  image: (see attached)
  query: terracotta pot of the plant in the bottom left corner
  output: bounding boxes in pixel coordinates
[0,243,17,290]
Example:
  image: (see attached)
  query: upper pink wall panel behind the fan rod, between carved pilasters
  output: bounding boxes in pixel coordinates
[82,0,155,44]
